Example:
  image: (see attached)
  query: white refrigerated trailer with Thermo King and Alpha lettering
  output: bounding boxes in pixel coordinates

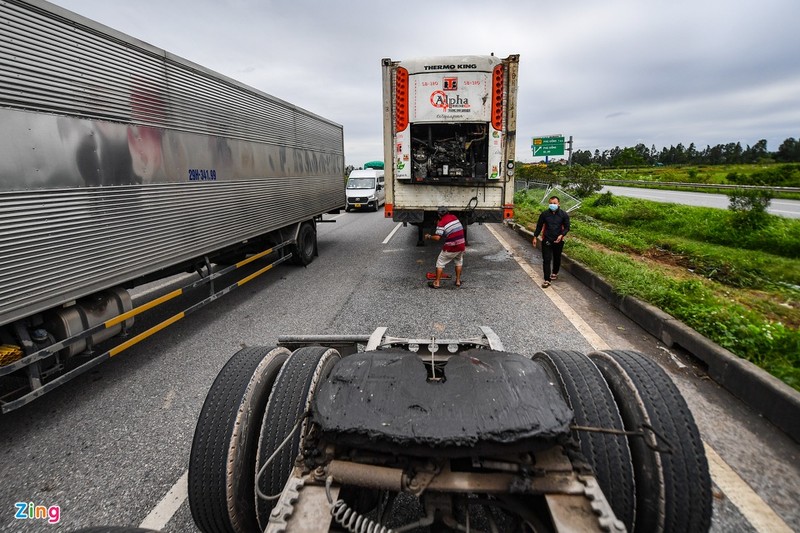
[383,55,519,244]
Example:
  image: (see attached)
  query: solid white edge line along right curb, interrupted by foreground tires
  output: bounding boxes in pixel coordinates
[486,224,792,533]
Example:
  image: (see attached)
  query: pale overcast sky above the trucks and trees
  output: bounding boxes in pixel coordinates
[48,0,800,166]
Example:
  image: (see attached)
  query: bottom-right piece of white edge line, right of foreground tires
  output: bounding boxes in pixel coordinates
[703,443,792,533]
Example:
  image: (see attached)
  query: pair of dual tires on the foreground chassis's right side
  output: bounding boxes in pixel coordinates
[533,350,712,533]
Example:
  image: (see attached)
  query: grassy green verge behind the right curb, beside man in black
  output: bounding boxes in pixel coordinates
[515,191,800,390]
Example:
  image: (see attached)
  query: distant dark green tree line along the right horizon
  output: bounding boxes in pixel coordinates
[572,137,800,167]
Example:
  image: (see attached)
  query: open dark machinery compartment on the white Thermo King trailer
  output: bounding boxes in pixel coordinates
[411,122,489,184]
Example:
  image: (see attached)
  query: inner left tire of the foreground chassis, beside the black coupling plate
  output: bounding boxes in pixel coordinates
[256,346,340,531]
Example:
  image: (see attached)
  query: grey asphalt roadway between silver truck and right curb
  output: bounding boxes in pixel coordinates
[0,211,800,532]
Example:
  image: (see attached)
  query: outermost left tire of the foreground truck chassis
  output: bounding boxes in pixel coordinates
[189,347,291,533]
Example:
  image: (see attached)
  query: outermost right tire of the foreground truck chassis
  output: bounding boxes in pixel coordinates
[589,350,712,532]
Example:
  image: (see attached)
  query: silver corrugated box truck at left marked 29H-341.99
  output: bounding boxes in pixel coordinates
[0,0,345,412]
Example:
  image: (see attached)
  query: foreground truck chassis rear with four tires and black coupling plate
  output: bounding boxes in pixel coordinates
[189,327,711,532]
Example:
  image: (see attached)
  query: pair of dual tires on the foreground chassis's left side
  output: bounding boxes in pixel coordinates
[188,347,339,533]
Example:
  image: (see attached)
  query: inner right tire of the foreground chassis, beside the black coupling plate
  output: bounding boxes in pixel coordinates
[533,350,636,531]
